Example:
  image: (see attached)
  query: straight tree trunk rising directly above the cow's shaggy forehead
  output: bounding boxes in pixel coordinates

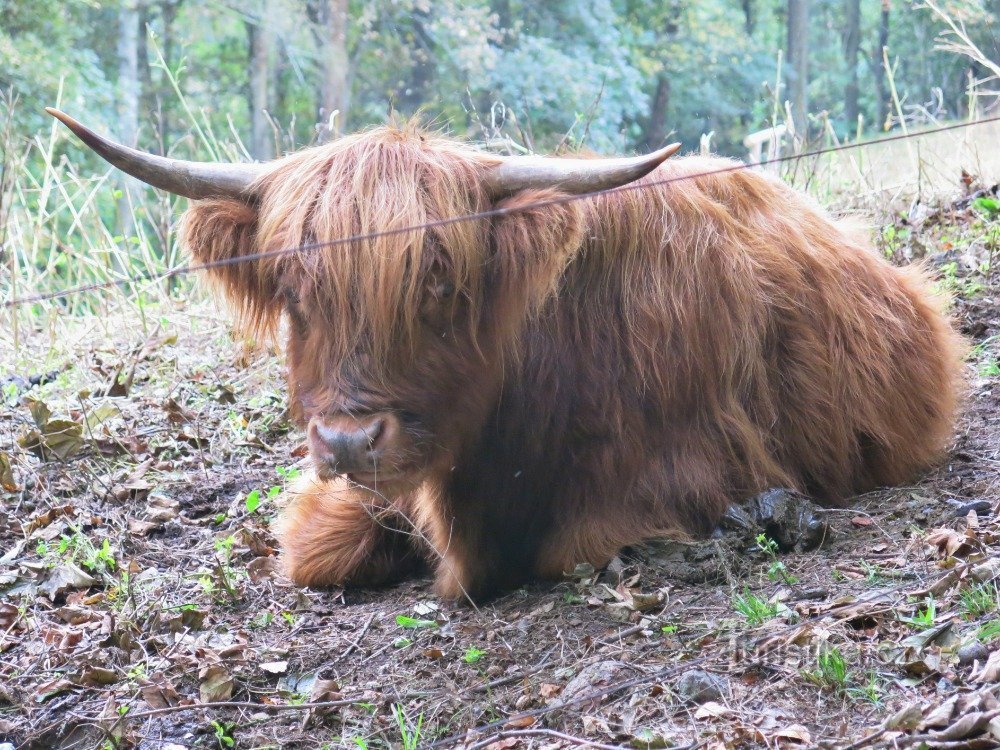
[317,0,351,143]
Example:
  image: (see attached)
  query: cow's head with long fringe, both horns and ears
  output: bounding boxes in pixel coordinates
[50,110,678,489]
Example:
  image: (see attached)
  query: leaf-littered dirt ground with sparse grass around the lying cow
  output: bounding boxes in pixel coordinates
[0,185,1000,750]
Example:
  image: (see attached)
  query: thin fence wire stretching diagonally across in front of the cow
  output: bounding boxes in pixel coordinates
[3,116,1000,310]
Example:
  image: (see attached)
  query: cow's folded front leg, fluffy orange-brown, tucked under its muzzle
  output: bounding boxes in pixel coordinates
[278,478,422,587]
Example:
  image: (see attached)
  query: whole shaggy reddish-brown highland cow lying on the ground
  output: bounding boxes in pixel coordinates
[48,108,963,597]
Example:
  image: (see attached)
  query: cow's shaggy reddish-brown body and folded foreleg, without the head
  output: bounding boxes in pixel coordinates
[264,150,961,595]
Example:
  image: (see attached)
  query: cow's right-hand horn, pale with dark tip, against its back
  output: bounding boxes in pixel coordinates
[486,143,681,198]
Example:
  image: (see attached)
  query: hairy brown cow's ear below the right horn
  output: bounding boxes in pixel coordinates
[489,190,584,314]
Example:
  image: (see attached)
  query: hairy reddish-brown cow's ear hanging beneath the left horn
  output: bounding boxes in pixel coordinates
[181,199,282,336]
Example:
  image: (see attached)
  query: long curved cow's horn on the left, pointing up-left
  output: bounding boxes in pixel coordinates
[45,107,264,200]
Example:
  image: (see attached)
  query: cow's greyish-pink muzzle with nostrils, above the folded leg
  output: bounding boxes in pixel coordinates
[308,413,401,484]
